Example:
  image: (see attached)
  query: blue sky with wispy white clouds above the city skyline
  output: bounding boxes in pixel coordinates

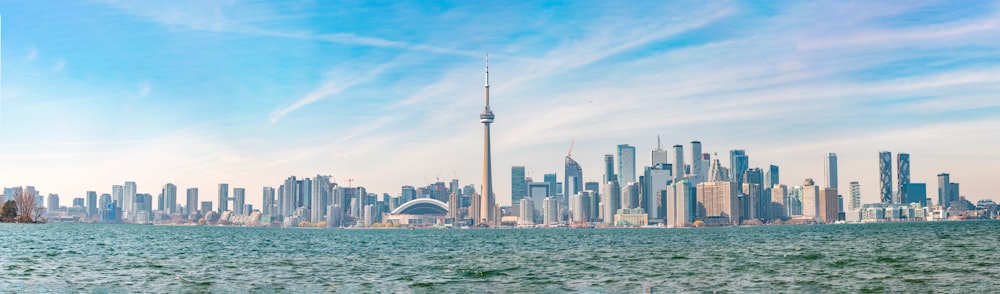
[0,1,1000,206]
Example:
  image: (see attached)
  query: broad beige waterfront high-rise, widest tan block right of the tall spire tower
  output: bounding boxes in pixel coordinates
[697,182,741,226]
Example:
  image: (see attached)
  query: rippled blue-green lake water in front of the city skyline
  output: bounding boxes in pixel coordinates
[0,221,1000,293]
